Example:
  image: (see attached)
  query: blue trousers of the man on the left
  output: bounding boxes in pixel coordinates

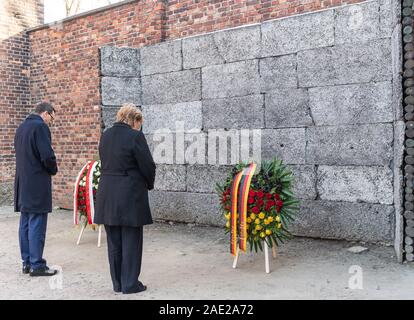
[19,212,48,270]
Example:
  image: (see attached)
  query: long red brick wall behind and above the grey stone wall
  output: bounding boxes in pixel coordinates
[30,0,368,208]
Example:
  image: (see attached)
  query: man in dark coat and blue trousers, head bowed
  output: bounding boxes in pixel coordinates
[14,102,58,277]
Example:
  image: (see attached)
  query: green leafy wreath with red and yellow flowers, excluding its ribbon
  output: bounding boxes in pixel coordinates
[216,159,299,252]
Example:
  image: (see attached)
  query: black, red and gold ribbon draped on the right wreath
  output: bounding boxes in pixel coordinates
[230,163,257,255]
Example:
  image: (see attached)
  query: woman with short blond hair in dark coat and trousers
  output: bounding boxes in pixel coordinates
[94,104,155,293]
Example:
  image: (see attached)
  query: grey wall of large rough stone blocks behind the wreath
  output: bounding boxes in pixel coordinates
[101,0,404,243]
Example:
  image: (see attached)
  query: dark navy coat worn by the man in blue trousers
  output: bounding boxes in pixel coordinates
[14,114,58,213]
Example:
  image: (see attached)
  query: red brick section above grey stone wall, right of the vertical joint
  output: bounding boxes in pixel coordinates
[166,0,362,39]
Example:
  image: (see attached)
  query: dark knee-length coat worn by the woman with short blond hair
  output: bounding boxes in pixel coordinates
[94,122,155,227]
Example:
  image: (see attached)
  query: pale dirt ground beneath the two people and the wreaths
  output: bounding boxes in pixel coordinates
[0,207,414,300]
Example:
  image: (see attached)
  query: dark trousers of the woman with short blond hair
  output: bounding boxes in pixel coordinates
[105,225,143,293]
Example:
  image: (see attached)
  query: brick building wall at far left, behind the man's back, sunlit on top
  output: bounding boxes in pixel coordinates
[0,0,43,203]
